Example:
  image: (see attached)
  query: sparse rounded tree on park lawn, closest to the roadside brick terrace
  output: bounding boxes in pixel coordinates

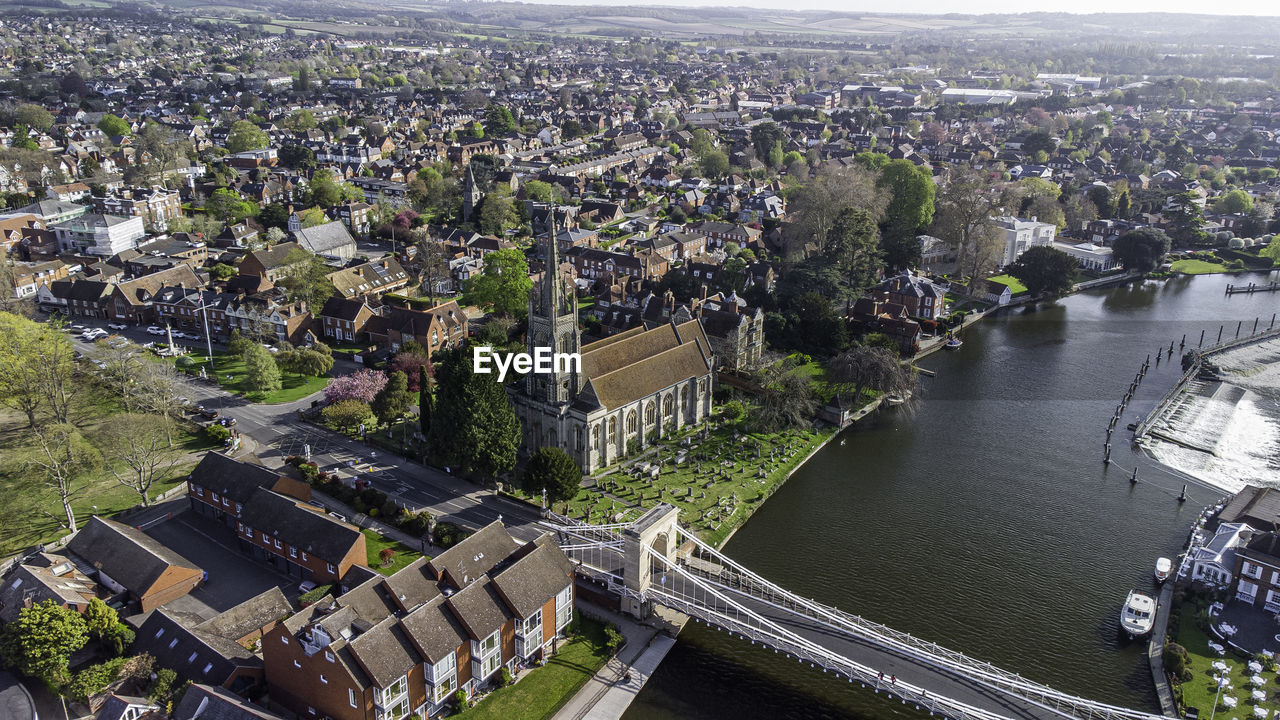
[97,414,186,506]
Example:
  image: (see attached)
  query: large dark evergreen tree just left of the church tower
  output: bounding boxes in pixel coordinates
[428,348,520,478]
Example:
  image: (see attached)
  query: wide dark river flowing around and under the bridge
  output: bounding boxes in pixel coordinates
[625,270,1280,720]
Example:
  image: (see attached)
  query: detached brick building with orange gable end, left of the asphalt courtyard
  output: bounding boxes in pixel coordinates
[67,515,205,612]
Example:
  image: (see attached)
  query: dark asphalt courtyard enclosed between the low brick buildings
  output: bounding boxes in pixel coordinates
[146,512,298,620]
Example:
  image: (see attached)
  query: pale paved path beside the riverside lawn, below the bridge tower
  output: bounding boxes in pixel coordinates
[552,601,678,720]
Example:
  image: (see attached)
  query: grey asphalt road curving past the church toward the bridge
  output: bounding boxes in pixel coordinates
[73,319,543,541]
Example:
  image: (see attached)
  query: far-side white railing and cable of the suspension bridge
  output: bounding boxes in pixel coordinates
[681,529,1161,720]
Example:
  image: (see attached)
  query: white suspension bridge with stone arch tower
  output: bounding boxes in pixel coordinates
[544,503,1164,720]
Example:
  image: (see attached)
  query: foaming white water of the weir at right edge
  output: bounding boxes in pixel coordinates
[1148,340,1280,492]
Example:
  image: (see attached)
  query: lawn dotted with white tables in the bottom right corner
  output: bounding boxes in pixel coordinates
[1172,603,1280,720]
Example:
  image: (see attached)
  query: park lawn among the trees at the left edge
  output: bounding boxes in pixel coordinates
[0,374,214,556]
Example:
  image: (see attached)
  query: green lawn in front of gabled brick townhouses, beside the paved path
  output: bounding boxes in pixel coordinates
[453,616,609,720]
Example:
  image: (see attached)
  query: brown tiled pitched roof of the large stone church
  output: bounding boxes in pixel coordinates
[582,320,712,407]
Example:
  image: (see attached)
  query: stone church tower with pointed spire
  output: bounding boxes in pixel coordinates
[525,224,582,405]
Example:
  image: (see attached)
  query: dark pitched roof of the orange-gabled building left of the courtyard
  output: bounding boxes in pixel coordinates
[67,516,202,597]
